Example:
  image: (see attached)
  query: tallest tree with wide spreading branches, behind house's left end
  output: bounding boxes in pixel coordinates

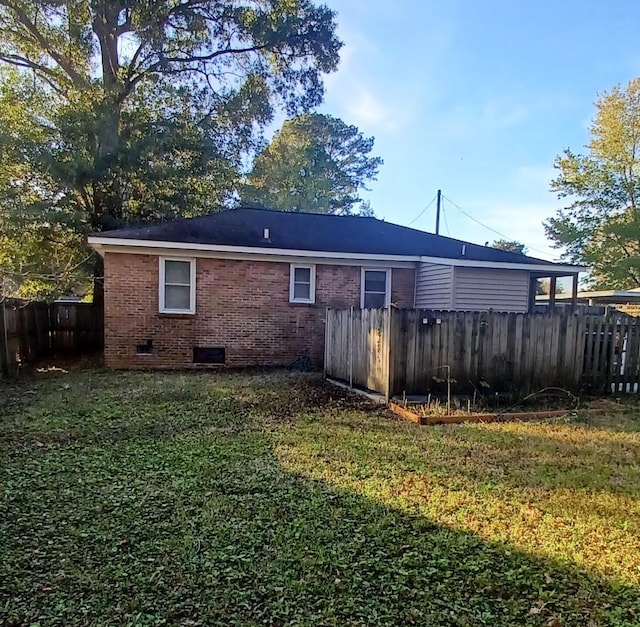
[0,0,341,300]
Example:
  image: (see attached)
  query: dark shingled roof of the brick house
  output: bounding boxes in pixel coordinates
[96,208,556,266]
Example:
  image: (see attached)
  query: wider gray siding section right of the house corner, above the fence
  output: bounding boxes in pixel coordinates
[453,267,529,313]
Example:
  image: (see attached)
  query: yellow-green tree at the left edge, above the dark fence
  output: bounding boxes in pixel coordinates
[0,71,89,299]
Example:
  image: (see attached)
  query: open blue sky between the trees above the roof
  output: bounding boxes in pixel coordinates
[320,0,640,259]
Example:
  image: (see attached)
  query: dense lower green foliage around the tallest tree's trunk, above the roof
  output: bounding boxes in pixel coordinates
[45,83,251,231]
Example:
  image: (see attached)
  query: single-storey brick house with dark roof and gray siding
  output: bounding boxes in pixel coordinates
[89,209,584,368]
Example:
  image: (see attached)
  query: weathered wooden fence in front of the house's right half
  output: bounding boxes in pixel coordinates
[325,309,640,397]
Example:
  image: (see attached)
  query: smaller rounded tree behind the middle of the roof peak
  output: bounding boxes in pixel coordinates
[241,113,382,215]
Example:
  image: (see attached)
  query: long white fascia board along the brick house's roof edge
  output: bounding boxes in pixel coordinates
[88,236,587,274]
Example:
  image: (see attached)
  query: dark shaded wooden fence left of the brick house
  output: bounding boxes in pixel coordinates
[0,298,104,376]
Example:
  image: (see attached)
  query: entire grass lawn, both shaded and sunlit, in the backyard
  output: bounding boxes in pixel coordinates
[0,370,640,627]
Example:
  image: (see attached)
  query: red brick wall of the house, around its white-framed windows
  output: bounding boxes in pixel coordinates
[105,253,414,368]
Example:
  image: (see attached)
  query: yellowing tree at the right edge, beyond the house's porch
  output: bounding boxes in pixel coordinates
[545,78,640,289]
